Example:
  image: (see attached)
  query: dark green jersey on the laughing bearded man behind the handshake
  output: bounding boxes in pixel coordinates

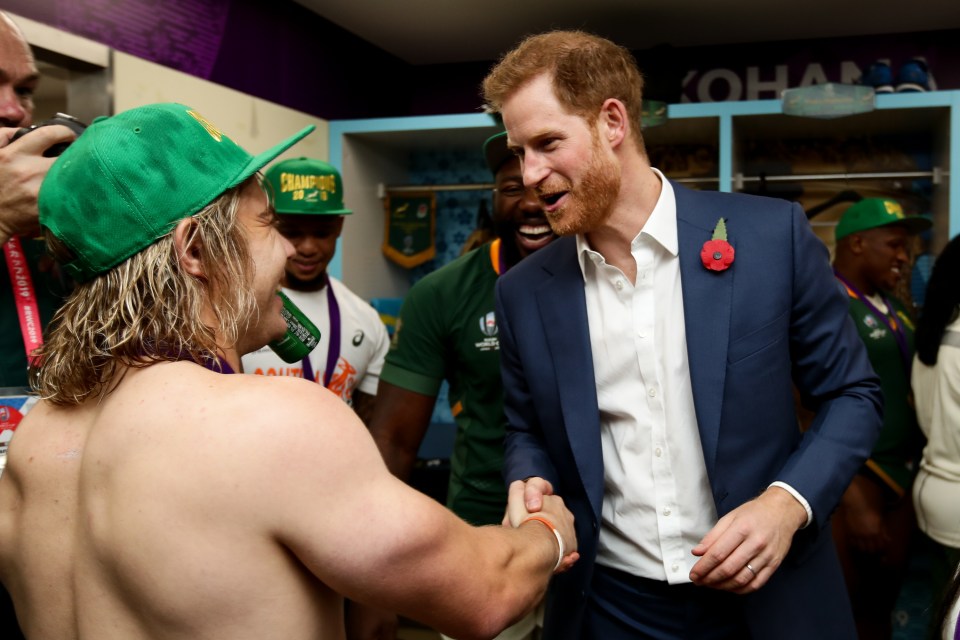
[380,241,507,525]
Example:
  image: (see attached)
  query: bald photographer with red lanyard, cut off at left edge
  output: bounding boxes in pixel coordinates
[0,11,74,640]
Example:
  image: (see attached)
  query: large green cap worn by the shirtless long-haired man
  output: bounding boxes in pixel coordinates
[39,103,315,282]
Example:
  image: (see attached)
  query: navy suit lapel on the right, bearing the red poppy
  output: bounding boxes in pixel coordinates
[673,184,737,477]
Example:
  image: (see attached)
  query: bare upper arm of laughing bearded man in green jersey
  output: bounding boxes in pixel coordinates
[367,380,437,481]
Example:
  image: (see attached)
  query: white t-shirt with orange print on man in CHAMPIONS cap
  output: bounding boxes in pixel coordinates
[243,277,390,404]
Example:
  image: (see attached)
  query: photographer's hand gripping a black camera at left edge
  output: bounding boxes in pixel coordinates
[0,125,76,244]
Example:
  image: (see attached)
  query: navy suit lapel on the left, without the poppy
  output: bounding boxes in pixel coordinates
[536,238,603,520]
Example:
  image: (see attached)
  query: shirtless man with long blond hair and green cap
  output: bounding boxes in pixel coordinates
[0,104,577,640]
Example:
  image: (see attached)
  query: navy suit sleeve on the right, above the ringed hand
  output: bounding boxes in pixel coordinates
[777,205,883,526]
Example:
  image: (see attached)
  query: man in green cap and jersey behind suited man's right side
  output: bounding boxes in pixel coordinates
[833,198,930,640]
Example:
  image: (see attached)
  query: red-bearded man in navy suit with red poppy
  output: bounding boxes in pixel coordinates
[484,32,882,640]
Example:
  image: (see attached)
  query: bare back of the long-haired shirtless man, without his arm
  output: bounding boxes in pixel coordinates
[0,363,342,640]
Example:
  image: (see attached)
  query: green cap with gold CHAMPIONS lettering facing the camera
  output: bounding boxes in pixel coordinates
[263,158,353,216]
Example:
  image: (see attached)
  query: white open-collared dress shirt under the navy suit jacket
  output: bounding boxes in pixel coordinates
[577,169,717,584]
